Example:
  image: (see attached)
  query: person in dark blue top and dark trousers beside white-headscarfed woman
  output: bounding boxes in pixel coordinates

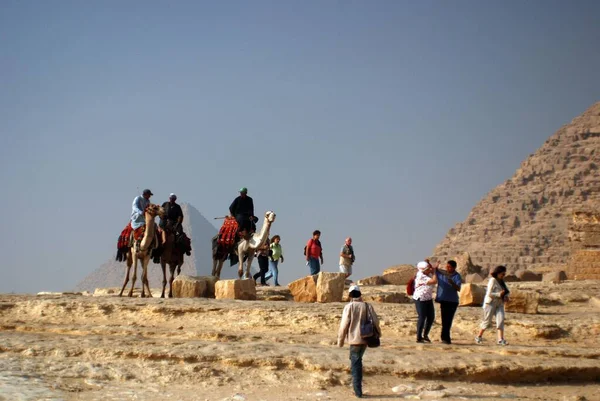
[435,260,462,344]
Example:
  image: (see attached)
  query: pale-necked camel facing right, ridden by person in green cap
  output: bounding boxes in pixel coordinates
[212,211,275,278]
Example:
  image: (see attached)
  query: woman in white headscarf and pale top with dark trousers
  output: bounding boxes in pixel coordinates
[413,261,439,343]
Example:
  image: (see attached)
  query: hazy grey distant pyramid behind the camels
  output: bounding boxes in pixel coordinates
[75,203,219,291]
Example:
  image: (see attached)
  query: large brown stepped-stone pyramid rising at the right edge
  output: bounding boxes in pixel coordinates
[434,102,600,271]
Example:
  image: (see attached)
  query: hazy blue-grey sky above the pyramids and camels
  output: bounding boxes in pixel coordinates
[0,0,600,293]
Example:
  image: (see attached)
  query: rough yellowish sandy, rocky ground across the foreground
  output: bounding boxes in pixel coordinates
[0,282,600,401]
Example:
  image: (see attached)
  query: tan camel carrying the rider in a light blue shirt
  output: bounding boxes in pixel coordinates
[119,203,165,298]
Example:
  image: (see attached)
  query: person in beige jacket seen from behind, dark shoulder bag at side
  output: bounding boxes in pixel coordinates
[338,285,381,398]
